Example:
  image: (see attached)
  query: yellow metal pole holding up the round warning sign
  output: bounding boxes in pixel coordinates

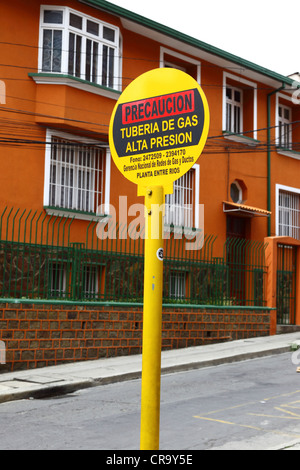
[140,186,164,450]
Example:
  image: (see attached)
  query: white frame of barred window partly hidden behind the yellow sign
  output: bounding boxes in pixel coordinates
[165,163,200,229]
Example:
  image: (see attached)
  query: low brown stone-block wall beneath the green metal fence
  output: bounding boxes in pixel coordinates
[0,303,270,372]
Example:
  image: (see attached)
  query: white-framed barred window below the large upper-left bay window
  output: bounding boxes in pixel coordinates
[44,135,105,213]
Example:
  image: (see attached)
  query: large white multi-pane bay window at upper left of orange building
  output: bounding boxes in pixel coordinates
[39,6,121,90]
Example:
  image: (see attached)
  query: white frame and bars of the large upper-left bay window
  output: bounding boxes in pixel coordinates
[38,5,122,91]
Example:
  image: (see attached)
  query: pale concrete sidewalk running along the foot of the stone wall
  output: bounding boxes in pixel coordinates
[0,332,300,403]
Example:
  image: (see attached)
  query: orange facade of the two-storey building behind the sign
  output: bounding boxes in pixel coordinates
[0,0,300,370]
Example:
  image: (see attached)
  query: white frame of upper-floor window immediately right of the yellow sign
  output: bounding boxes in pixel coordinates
[222,72,257,145]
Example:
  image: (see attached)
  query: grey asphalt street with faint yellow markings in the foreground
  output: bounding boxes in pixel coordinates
[0,353,300,451]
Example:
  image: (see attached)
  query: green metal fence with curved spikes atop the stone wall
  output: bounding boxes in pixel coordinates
[0,209,266,306]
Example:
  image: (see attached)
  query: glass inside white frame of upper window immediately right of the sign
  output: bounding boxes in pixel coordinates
[225,86,243,134]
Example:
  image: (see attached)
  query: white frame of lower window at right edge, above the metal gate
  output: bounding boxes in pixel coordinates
[275,184,300,240]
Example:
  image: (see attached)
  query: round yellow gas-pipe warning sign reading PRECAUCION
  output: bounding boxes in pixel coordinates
[109,68,209,195]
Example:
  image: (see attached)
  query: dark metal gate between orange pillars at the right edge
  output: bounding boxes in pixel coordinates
[277,245,297,325]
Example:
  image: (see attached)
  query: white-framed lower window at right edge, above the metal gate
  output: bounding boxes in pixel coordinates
[277,186,300,240]
